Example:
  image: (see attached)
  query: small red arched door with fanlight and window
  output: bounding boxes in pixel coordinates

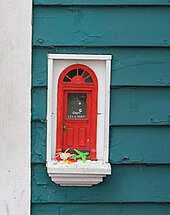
[57,64,97,160]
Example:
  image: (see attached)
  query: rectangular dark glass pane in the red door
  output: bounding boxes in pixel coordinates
[67,93,87,119]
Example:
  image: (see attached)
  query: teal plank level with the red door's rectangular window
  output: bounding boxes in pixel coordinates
[32,88,170,125]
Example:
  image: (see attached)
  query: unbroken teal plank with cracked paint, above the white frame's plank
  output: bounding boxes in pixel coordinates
[33,6,170,46]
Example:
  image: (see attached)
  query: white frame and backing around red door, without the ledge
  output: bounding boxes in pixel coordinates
[47,54,111,186]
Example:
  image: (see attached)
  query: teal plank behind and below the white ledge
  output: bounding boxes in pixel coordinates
[32,164,170,203]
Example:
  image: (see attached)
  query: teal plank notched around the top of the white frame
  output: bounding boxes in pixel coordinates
[32,47,170,86]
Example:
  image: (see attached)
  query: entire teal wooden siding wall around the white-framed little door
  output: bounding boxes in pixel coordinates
[32,0,170,215]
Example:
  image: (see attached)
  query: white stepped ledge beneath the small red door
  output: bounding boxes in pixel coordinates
[47,160,111,186]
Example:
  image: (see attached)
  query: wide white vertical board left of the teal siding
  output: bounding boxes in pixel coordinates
[0,0,32,215]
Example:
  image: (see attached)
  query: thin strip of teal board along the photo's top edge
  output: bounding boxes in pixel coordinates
[33,0,170,6]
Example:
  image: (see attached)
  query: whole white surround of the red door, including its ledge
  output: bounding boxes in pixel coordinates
[47,54,112,186]
